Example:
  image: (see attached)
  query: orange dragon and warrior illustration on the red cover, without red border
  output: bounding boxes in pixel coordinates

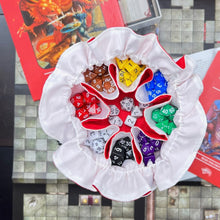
[17,0,106,68]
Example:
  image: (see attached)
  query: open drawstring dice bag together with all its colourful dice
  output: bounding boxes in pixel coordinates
[39,27,207,201]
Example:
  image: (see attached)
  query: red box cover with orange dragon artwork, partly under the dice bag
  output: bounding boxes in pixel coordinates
[0,0,124,100]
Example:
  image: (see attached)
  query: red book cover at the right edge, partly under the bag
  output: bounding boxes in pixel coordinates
[189,51,220,187]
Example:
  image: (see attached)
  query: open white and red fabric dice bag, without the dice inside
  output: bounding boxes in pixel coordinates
[39,28,206,201]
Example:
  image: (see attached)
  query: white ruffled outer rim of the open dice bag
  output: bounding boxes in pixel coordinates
[39,28,206,201]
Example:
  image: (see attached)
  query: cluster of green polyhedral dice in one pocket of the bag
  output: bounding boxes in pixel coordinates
[152,104,177,135]
